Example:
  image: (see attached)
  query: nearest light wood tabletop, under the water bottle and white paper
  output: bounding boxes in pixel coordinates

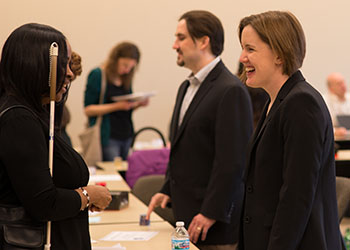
[90,221,198,250]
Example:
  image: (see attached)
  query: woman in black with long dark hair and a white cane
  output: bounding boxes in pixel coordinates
[0,24,111,250]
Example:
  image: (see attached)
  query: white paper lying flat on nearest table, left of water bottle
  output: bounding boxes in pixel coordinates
[100,231,158,241]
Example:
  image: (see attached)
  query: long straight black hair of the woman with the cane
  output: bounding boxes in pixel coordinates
[0,23,68,113]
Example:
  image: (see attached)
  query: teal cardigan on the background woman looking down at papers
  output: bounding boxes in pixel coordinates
[84,68,111,146]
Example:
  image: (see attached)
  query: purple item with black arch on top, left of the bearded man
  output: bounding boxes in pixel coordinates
[125,127,170,188]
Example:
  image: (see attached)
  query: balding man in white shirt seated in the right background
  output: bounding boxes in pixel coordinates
[325,72,350,136]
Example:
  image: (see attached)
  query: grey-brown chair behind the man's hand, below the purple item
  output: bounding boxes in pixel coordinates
[131,175,176,226]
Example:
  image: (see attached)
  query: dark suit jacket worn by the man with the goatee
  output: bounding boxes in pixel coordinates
[161,61,252,244]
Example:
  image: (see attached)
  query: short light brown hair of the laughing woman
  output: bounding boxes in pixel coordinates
[238,11,306,76]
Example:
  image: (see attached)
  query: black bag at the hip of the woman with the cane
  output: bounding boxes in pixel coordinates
[0,207,46,250]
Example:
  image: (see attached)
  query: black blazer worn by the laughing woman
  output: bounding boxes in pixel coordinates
[239,71,340,250]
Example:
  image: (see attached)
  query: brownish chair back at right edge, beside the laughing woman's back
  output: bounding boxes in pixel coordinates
[336,176,350,222]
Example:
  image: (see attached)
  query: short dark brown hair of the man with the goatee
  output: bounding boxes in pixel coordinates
[179,10,224,56]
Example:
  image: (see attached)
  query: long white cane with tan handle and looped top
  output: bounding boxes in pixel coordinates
[45,42,58,250]
